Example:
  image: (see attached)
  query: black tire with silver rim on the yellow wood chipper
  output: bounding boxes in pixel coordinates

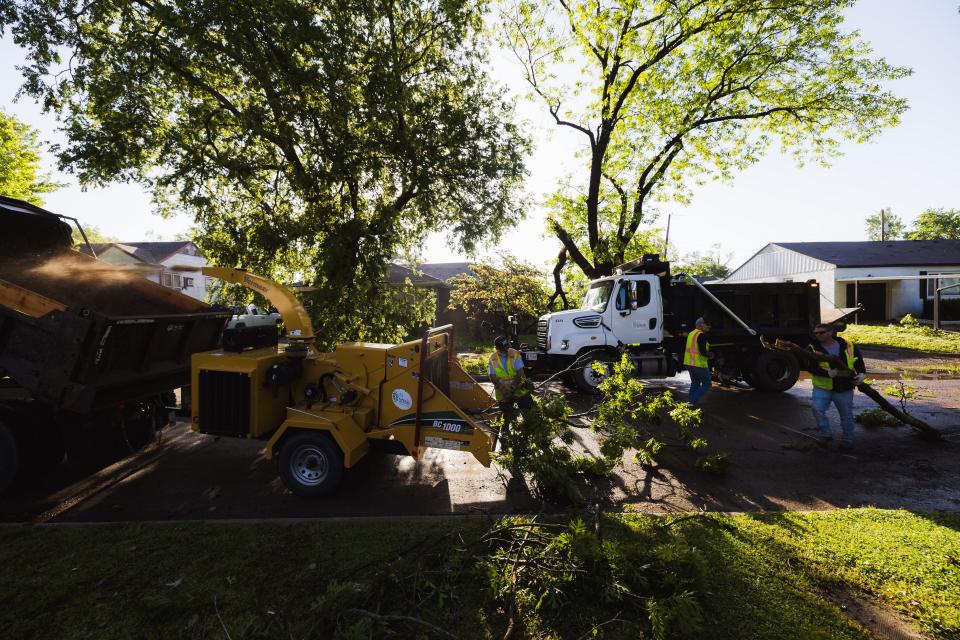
[279,432,343,498]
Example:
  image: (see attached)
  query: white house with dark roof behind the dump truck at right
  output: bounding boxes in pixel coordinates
[724,240,960,322]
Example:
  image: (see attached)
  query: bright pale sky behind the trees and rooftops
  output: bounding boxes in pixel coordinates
[0,0,960,267]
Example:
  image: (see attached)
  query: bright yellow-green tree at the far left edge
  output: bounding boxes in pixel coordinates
[0,110,60,205]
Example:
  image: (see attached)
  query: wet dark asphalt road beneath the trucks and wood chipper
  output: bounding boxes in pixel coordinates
[0,354,960,522]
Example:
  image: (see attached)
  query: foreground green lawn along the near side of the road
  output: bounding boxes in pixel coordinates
[0,509,960,640]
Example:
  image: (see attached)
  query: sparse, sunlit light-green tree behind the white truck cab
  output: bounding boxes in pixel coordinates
[503,0,909,300]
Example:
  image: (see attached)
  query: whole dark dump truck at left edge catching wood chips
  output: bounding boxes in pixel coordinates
[0,196,231,491]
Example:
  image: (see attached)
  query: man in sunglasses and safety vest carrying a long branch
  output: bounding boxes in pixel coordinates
[808,324,867,449]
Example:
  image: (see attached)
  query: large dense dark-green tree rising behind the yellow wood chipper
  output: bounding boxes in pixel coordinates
[0,0,527,344]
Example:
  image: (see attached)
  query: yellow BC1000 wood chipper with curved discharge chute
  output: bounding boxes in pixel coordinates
[192,267,496,497]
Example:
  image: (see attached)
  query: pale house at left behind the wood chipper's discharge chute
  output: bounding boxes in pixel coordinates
[79,240,209,300]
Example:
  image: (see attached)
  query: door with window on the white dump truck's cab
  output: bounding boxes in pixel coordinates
[610,276,663,344]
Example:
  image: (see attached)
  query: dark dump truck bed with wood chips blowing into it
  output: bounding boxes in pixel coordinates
[0,197,230,413]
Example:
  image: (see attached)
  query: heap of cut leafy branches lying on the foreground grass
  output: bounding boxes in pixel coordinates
[478,514,704,640]
